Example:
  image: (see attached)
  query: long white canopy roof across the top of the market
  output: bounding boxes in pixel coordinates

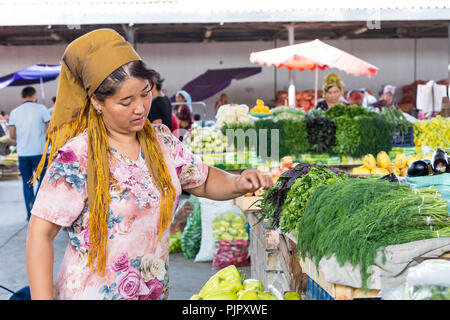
[0,0,450,26]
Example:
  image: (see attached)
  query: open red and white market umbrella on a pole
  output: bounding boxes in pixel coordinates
[250,39,378,107]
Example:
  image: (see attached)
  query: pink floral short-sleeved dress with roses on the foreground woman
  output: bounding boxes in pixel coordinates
[32,125,208,300]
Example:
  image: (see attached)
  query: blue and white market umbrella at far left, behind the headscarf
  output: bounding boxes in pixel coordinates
[0,64,61,96]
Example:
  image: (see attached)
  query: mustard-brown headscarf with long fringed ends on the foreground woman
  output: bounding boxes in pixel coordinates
[35,29,175,275]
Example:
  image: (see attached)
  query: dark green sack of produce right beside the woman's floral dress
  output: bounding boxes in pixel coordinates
[180,198,202,259]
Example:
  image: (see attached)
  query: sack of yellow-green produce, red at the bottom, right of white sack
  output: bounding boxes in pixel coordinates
[212,212,250,269]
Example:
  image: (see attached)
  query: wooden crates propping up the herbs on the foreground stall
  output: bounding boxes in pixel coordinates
[234,197,450,300]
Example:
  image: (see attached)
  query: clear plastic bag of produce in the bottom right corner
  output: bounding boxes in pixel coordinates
[404,259,450,300]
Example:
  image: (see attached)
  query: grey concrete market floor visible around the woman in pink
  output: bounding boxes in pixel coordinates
[0,180,251,300]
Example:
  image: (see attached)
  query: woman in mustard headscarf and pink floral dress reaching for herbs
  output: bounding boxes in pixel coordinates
[26,29,272,300]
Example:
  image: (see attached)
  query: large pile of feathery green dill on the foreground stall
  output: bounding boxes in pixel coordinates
[297,179,450,290]
